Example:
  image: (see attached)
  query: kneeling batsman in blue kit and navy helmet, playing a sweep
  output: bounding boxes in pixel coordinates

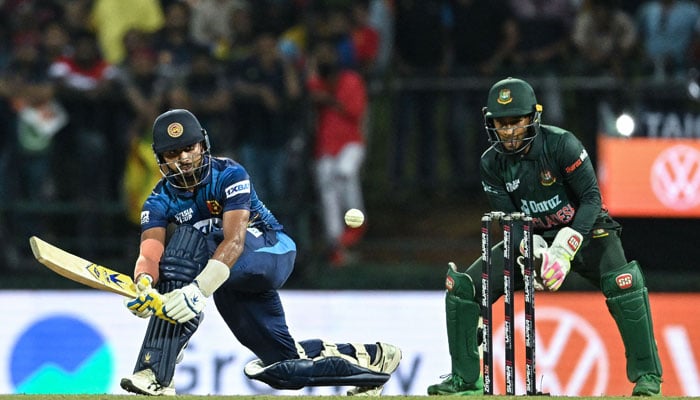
[121,109,401,395]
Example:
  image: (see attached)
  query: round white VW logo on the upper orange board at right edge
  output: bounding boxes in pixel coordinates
[650,145,700,210]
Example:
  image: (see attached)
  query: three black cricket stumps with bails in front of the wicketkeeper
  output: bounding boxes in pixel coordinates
[481,211,539,396]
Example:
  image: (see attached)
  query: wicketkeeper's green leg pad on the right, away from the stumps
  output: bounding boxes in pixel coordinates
[601,261,662,382]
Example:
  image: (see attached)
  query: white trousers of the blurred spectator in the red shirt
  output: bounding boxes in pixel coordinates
[314,143,365,245]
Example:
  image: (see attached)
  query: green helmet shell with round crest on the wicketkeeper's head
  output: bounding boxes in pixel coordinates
[484,77,537,119]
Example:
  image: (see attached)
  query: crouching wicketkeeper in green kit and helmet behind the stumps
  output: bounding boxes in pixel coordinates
[428,78,662,396]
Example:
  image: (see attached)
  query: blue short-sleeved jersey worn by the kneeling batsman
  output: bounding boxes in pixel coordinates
[141,157,283,234]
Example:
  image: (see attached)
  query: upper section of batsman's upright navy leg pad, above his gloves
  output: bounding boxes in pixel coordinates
[160,225,209,282]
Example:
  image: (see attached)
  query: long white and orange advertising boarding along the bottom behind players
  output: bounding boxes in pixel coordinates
[0,290,700,396]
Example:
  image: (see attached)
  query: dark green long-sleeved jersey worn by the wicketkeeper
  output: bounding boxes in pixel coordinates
[481,125,612,237]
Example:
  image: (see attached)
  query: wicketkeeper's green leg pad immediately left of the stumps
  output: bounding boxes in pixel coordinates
[445,268,481,383]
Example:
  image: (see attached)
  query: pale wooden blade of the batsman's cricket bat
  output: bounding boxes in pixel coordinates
[29,236,137,297]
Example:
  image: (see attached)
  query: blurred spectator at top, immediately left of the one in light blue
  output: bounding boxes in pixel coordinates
[572,0,637,78]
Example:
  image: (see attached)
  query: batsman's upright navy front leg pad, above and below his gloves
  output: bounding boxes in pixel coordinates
[134,225,209,386]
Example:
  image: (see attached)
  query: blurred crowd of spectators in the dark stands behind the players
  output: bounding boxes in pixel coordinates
[0,0,700,266]
